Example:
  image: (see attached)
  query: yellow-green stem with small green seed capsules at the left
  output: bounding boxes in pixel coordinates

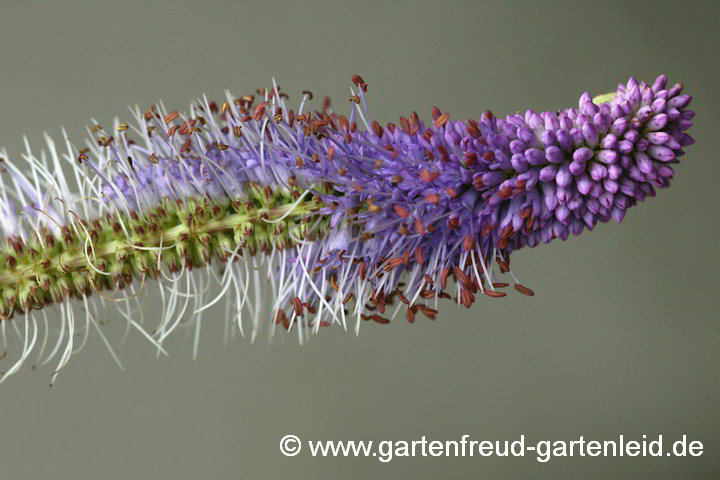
[0,199,321,319]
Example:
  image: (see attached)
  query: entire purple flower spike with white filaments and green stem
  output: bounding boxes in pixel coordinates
[0,75,694,380]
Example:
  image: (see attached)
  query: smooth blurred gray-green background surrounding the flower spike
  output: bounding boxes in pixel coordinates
[0,1,720,480]
